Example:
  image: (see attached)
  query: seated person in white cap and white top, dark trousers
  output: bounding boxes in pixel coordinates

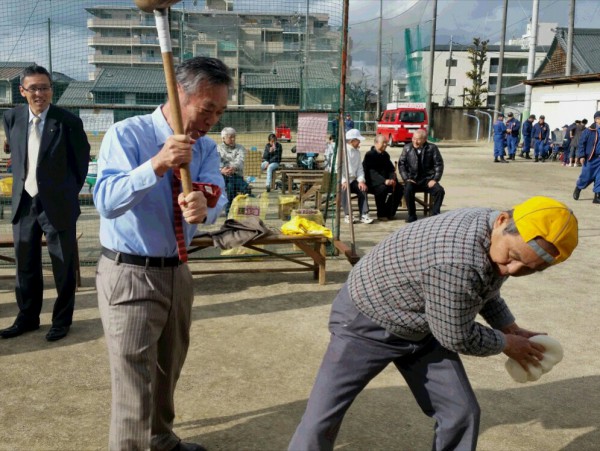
[342,128,373,224]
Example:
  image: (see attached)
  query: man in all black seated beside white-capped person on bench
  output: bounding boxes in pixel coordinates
[363,135,404,221]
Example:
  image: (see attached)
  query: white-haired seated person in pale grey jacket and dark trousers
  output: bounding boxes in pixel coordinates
[217,127,251,214]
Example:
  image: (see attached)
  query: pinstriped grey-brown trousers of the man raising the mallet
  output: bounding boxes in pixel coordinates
[96,256,194,451]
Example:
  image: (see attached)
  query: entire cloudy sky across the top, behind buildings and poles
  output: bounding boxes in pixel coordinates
[0,0,600,82]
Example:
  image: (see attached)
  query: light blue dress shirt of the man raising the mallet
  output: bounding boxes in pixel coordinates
[94,106,227,257]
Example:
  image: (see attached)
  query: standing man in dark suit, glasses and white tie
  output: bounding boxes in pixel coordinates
[0,65,90,341]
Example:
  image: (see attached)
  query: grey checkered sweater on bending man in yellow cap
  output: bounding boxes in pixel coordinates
[348,208,514,356]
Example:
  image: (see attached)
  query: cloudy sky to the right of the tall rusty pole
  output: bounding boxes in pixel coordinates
[349,0,600,84]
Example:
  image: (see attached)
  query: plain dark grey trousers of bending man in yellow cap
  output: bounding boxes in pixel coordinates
[288,285,480,451]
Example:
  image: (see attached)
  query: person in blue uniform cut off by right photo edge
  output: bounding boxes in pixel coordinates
[573,111,600,204]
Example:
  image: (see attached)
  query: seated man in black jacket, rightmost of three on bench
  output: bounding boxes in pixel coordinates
[398,130,446,222]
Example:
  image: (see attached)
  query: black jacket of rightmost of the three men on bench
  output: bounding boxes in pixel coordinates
[398,142,444,183]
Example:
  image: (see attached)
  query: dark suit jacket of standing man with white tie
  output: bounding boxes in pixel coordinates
[4,105,90,230]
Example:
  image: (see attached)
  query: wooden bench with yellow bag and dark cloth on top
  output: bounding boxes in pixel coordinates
[188,234,328,285]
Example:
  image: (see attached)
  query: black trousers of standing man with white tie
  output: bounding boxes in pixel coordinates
[13,192,77,327]
